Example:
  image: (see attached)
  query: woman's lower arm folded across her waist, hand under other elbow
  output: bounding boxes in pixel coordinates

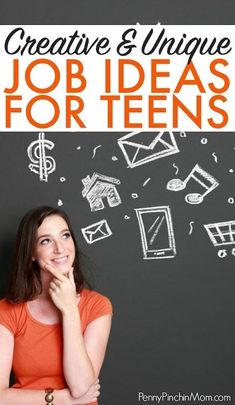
[0,325,100,405]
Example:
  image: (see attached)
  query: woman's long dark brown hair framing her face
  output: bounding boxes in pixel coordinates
[6,206,91,303]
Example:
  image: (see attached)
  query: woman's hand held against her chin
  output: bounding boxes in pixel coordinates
[45,264,80,314]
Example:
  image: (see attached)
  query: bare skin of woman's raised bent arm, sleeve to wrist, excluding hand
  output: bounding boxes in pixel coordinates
[63,308,111,396]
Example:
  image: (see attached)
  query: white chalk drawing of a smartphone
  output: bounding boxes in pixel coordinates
[135,206,176,259]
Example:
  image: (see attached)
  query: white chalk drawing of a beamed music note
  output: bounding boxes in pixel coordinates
[166,164,219,204]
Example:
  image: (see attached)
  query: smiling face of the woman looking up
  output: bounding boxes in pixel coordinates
[32,215,75,274]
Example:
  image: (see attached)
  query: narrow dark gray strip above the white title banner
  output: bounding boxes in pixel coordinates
[0,0,235,25]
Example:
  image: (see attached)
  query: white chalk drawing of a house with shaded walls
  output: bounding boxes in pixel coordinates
[82,173,122,212]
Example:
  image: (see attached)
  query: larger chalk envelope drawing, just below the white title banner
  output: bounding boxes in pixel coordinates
[118,131,179,168]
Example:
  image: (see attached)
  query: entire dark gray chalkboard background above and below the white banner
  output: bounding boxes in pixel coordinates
[0,0,235,405]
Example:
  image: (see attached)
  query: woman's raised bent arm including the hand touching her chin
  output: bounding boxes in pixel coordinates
[46,265,111,397]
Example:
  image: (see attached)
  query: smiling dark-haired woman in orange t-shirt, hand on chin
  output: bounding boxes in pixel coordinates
[0,207,112,405]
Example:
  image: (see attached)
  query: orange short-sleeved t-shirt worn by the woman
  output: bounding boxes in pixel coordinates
[0,288,112,402]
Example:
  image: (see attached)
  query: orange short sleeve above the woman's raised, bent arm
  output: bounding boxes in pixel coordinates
[88,292,113,323]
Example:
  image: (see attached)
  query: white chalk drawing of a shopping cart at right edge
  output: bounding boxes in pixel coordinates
[204,221,235,258]
